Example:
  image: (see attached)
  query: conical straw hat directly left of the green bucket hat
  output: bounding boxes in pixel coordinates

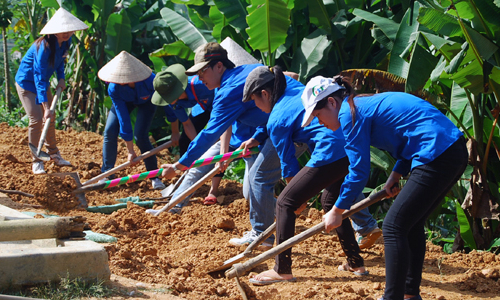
[97,51,153,84]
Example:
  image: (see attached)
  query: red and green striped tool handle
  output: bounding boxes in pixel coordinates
[73,147,259,193]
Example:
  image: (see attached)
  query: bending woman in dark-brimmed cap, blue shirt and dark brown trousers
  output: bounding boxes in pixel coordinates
[242,66,368,285]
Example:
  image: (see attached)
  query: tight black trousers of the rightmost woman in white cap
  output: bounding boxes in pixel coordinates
[383,137,468,300]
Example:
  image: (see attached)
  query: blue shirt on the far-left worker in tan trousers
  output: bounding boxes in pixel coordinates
[16,38,71,104]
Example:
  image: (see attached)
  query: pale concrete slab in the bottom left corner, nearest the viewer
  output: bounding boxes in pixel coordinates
[0,239,111,289]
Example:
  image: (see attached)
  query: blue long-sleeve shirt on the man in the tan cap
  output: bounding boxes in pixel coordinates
[179,64,269,166]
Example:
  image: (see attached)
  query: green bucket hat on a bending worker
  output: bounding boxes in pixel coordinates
[151,64,187,106]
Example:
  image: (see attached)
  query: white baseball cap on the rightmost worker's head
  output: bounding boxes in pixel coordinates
[302,76,345,127]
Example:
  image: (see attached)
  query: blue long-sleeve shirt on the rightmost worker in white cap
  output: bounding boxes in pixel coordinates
[335,92,463,209]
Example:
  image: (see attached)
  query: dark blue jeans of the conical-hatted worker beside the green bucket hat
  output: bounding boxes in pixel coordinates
[101,102,158,172]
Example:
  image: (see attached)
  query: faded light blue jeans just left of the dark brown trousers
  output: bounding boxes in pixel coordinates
[243,138,281,243]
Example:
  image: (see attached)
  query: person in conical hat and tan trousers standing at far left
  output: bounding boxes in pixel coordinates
[15,8,88,174]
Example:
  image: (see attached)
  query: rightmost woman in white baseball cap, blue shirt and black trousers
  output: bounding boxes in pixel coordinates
[302,76,468,300]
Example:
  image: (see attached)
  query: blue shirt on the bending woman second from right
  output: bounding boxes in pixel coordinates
[267,76,346,178]
